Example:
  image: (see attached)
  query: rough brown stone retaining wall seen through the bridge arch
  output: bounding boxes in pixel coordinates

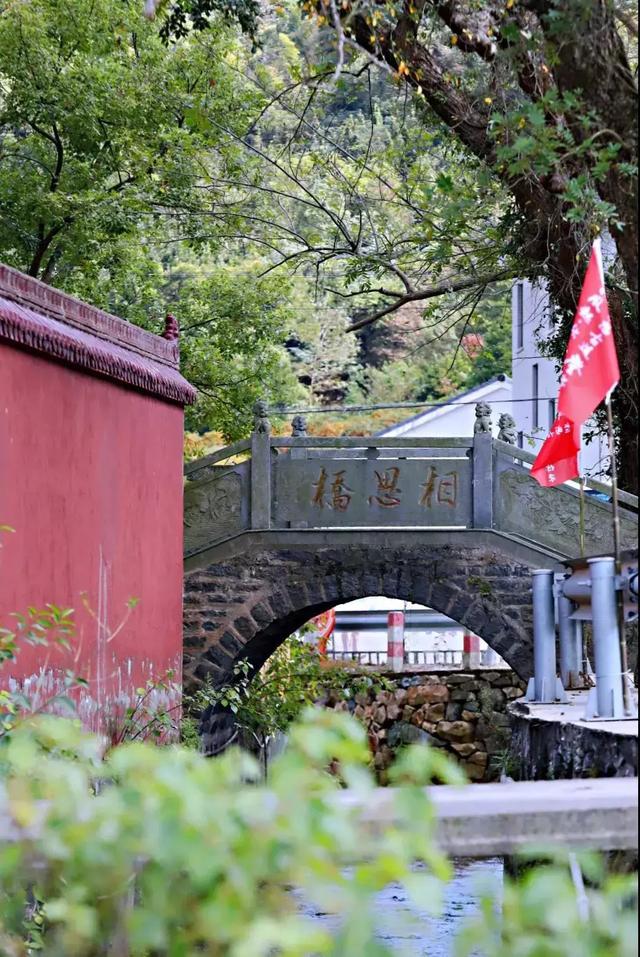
[320,670,524,784]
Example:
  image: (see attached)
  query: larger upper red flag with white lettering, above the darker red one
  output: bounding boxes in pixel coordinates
[558,239,620,425]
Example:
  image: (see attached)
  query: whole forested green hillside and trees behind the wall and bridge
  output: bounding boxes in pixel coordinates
[0,0,509,439]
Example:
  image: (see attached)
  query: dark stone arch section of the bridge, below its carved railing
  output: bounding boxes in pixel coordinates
[184,535,535,687]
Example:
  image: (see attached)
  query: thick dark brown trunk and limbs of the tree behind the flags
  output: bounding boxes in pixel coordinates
[336,0,638,486]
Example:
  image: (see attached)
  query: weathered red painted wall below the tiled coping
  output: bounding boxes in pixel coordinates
[0,345,183,731]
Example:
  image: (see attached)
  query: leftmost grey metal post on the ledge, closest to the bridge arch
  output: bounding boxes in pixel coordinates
[525,568,566,704]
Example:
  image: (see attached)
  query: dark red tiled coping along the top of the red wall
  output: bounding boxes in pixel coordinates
[0,264,196,405]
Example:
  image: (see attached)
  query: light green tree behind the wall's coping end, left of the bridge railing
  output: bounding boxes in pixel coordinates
[75,247,305,441]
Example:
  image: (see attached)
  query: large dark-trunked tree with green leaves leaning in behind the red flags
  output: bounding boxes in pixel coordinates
[306,0,638,491]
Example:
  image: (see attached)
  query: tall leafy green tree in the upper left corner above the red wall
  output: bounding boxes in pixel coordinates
[0,0,250,282]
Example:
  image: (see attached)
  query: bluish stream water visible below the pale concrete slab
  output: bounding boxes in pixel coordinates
[300,857,503,957]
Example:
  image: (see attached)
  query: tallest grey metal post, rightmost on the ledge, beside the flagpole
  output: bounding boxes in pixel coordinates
[585,558,625,718]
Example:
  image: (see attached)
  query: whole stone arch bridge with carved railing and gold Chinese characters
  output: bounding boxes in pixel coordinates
[184,419,637,704]
